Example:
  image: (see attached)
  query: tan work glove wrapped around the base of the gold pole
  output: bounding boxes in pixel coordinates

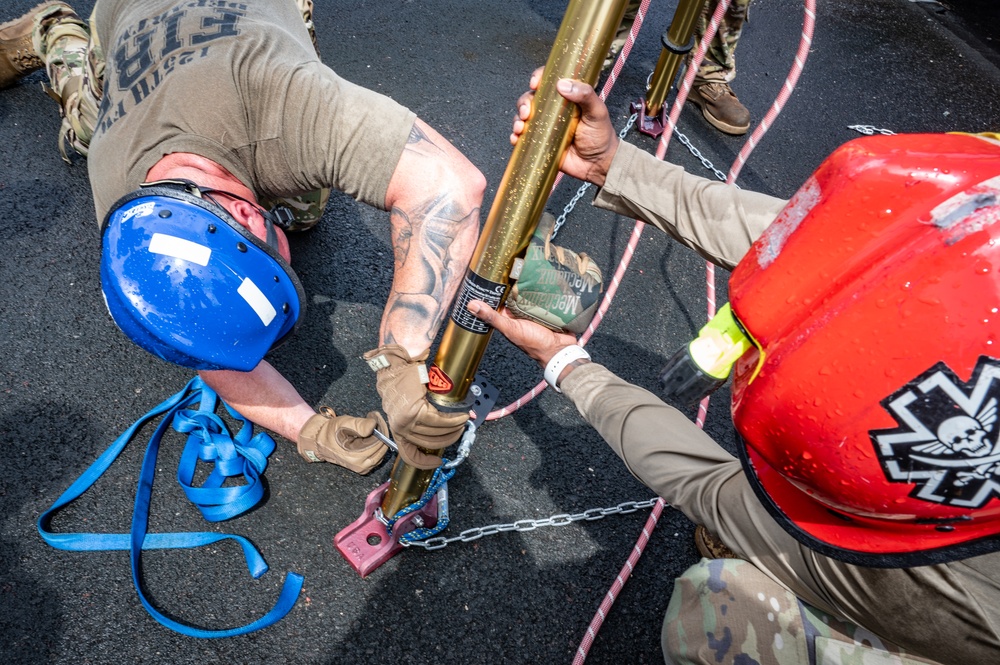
[362,344,469,469]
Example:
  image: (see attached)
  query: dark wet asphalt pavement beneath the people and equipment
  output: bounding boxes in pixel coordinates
[0,0,1000,664]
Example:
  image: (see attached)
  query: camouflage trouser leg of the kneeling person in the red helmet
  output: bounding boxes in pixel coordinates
[661,559,934,665]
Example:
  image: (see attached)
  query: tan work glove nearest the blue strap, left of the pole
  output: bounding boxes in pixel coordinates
[298,406,389,475]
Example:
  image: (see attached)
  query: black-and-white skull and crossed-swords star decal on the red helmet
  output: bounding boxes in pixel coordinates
[869,356,1000,508]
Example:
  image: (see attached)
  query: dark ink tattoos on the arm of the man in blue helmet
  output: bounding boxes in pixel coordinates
[382,125,479,345]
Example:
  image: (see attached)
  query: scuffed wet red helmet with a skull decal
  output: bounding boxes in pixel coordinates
[729,134,1000,566]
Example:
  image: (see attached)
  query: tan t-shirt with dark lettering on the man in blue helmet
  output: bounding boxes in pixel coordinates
[88,0,415,221]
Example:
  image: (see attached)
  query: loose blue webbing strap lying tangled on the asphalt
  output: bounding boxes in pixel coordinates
[38,377,302,638]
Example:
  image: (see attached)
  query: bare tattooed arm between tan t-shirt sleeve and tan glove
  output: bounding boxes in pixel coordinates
[379,118,486,356]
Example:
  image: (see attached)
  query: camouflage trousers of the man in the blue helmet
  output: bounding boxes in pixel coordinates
[31,0,330,231]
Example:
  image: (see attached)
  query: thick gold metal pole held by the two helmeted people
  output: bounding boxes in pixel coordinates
[382,0,628,518]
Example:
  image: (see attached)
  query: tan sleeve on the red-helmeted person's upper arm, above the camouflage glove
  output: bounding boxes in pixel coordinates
[594,141,786,270]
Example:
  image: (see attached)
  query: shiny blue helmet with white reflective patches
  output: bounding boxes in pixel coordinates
[101,181,305,371]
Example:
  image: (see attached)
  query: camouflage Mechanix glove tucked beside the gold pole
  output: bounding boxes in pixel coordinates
[507,213,604,335]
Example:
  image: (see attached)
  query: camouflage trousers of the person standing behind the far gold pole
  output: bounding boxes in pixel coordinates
[605,0,750,83]
